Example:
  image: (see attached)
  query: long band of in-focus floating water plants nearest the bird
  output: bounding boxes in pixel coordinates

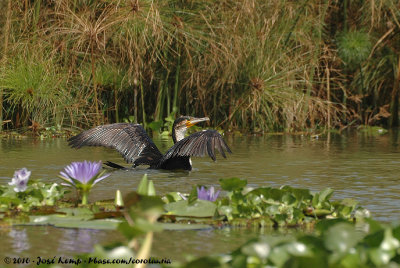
[0,177,362,229]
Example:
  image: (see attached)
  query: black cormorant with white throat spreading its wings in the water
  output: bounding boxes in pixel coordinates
[68,116,232,170]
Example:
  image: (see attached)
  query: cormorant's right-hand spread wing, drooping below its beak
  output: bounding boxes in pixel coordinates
[161,129,232,162]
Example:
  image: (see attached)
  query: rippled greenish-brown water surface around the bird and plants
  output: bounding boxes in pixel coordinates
[0,132,400,261]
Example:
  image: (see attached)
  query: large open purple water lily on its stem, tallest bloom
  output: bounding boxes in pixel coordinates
[58,161,110,204]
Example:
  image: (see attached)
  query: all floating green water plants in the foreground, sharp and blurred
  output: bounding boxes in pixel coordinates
[0,172,400,267]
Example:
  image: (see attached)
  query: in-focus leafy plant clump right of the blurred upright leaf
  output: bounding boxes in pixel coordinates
[164,178,365,228]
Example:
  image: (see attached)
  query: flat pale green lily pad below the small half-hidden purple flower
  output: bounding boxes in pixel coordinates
[164,200,217,217]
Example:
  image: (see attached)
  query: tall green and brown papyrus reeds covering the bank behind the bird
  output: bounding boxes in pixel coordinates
[0,0,400,131]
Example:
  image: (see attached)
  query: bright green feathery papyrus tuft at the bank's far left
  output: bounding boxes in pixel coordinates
[0,47,71,126]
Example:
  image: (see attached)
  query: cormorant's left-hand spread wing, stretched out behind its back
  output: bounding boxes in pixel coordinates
[68,123,162,165]
